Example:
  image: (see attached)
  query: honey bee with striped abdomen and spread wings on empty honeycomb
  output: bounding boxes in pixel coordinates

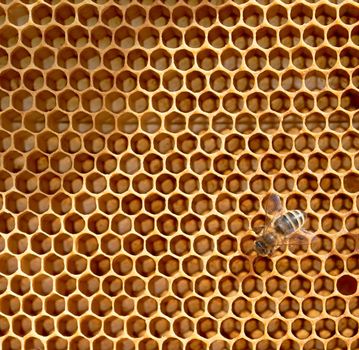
[254,194,312,255]
